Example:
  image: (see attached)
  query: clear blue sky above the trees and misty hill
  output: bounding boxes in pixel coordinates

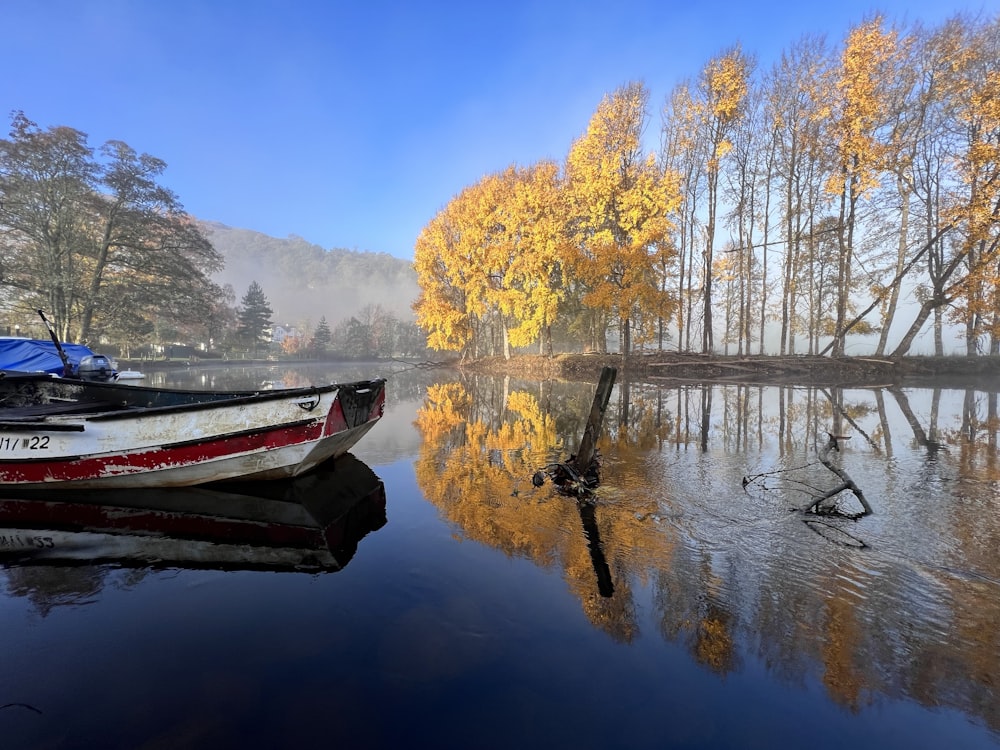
[0,0,1000,258]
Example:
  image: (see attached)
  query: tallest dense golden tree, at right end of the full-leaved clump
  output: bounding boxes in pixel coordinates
[566,83,680,356]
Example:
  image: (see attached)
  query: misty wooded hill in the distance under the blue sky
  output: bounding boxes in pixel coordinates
[199,221,419,328]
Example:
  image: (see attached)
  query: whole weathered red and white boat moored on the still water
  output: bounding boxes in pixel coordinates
[0,371,385,489]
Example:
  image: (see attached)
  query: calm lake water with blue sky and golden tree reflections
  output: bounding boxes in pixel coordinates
[0,365,1000,750]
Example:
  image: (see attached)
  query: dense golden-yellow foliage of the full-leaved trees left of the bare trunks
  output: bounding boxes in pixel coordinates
[414,84,680,353]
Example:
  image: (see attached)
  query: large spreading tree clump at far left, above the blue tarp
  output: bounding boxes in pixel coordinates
[0,112,221,341]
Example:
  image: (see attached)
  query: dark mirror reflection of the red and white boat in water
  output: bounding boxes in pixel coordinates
[0,454,386,572]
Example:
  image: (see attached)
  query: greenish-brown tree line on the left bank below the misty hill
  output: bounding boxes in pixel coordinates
[0,112,425,358]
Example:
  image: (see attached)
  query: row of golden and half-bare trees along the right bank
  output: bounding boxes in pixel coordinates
[414,16,1000,356]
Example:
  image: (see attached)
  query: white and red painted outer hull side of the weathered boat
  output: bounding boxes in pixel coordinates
[0,381,384,489]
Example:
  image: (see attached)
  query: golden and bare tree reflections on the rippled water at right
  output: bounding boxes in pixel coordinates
[416,376,1000,730]
